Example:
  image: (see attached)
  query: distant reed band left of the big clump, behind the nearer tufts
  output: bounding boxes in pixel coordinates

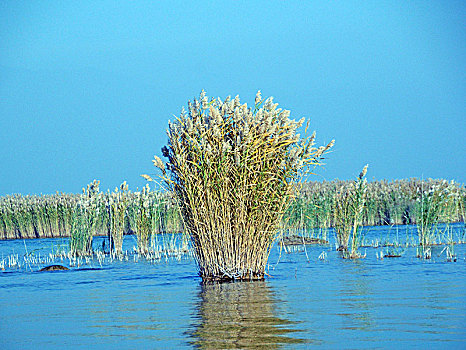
[0,191,183,239]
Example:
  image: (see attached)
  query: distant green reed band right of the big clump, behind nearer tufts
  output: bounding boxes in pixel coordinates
[285,178,466,231]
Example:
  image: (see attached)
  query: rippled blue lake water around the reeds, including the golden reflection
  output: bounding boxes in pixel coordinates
[0,226,466,349]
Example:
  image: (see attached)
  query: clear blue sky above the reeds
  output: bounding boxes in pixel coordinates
[0,1,466,195]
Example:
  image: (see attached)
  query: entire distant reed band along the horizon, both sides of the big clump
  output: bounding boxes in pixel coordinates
[0,179,466,239]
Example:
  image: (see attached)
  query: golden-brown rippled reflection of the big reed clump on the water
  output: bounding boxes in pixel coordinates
[191,281,303,349]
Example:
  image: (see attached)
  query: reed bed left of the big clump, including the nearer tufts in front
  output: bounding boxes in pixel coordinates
[0,180,183,250]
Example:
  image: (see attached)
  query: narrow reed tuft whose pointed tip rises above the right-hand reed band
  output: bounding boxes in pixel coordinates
[334,165,368,258]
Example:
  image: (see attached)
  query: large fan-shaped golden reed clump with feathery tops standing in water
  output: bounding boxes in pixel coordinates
[147,92,333,280]
